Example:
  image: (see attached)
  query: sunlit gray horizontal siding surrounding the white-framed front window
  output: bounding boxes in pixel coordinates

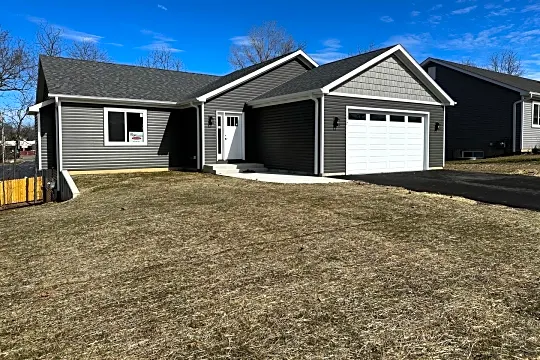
[61,103,171,170]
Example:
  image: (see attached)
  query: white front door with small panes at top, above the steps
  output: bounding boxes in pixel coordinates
[223,113,244,160]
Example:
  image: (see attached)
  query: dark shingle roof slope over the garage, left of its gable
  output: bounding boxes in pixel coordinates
[255,46,394,100]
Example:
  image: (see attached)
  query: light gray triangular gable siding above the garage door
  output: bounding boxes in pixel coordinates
[334,56,439,102]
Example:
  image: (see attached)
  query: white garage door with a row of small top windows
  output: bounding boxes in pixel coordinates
[346,109,426,174]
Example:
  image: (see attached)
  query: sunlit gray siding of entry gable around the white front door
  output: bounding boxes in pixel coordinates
[204,59,307,164]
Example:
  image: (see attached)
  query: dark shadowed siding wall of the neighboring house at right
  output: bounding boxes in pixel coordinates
[425,63,521,160]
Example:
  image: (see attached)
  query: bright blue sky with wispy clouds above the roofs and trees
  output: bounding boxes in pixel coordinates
[0,0,540,79]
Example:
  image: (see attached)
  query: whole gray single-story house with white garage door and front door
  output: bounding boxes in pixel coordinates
[30,45,454,180]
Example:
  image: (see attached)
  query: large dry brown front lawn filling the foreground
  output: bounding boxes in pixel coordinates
[0,173,540,359]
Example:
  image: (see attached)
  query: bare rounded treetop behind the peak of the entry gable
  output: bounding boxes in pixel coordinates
[229,21,305,69]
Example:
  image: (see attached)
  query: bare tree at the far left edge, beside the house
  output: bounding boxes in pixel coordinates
[0,28,36,95]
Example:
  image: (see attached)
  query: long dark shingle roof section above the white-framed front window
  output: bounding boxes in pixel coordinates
[40,56,219,102]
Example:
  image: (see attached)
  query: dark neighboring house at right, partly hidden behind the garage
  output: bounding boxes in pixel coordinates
[422,58,540,159]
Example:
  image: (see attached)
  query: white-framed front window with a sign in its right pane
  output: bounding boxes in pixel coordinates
[103,108,148,146]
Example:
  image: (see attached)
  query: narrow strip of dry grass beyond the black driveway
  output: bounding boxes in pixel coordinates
[445,154,540,176]
